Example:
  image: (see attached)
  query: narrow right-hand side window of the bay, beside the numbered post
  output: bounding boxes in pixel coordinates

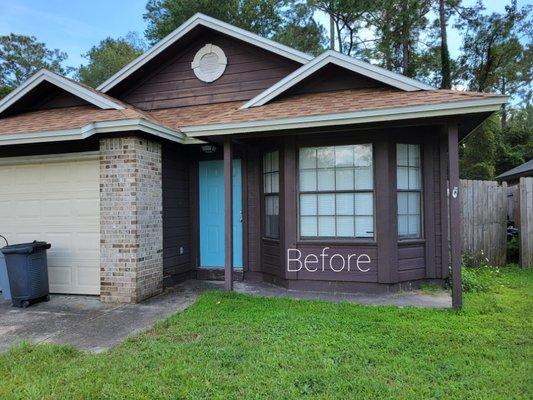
[396,144,422,239]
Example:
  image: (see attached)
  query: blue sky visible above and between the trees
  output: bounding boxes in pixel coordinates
[0,0,533,67]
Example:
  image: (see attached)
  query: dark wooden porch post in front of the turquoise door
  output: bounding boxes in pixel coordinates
[224,137,233,290]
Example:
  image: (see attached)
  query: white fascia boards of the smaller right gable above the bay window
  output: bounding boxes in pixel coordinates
[241,50,435,108]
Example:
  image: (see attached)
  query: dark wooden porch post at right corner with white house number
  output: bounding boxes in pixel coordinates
[448,124,463,308]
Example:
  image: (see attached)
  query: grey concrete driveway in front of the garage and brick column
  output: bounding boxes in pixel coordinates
[0,281,213,352]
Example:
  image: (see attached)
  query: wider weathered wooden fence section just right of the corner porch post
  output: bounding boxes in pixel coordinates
[460,180,508,265]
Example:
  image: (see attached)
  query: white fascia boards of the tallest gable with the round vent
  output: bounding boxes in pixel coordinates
[97,13,313,93]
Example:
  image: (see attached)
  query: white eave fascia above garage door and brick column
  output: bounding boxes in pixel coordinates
[0,119,185,146]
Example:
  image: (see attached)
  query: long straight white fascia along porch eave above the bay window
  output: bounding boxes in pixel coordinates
[185,96,507,137]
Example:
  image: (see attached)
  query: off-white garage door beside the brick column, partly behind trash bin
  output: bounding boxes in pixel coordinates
[0,153,100,294]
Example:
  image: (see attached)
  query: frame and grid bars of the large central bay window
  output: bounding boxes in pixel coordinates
[295,140,377,244]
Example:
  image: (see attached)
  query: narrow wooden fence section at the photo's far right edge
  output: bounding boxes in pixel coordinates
[518,178,533,267]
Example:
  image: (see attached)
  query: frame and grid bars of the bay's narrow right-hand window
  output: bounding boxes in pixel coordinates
[394,141,426,239]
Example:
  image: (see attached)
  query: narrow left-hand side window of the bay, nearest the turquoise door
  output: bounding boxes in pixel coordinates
[263,151,279,239]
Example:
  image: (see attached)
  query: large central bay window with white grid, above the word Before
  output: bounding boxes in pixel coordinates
[298,144,374,238]
